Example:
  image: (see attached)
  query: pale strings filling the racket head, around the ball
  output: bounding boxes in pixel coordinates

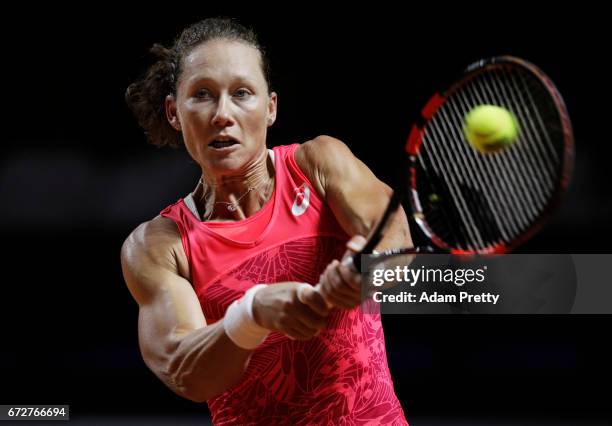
[417,67,563,251]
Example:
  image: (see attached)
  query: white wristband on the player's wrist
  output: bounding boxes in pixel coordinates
[223,284,270,349]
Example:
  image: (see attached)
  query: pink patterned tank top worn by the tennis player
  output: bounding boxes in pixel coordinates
[161,144,407,425]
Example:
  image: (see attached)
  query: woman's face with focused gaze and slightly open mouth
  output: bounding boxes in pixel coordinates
[166,39,276,175]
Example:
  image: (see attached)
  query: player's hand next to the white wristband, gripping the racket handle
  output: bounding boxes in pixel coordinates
[253,282,329,340]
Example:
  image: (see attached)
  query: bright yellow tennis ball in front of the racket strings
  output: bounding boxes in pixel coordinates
[463,105,519,154]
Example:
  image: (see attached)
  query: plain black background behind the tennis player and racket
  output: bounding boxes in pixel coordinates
[0,3,612,424]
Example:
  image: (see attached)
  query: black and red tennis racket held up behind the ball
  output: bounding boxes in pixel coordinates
[334,56,574,271]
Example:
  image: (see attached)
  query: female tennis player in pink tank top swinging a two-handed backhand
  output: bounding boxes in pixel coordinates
[121,18,411,425]
